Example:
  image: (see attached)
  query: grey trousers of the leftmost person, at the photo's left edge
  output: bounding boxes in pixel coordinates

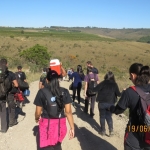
[0,101,8,132]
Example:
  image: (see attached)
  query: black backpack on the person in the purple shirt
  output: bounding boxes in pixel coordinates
[86,74,97,96]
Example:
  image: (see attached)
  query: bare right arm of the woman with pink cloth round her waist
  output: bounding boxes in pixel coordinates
[65,103,74,139]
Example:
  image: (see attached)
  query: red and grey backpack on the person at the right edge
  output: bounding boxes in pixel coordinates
[130,86,150,144]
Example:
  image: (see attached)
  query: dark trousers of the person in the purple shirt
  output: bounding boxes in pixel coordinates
[84,95,96,114]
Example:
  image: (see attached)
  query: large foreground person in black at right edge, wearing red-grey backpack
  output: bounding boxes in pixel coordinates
[110,63,150,150]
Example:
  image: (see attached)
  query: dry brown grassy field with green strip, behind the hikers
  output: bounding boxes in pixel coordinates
[0,28,150,89]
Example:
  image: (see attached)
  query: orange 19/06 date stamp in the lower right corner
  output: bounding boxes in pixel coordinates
[128,125,150,132]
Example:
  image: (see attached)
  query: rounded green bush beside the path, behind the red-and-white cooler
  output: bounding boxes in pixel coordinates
[20,44,50,67]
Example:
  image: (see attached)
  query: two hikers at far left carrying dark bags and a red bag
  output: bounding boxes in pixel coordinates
[0,58,29,133]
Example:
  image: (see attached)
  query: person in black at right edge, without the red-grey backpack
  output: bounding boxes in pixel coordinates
[110,63,150,150]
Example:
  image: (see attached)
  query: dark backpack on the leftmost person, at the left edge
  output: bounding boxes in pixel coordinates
[0,64,12,100]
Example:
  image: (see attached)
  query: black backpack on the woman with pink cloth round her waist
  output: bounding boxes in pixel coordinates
[41,88,65,119]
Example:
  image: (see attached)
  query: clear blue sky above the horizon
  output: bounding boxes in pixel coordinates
[0,0,150,28]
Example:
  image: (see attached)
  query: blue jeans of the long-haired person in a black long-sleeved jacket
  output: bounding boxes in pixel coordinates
[98,103,113,132]
